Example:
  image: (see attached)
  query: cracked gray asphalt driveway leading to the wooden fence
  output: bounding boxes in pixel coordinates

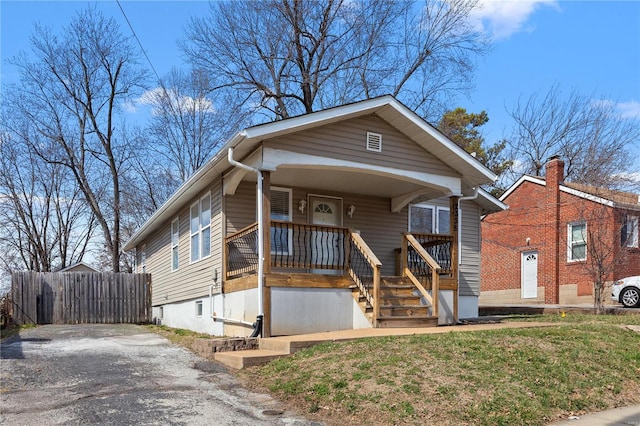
[0,324,320,426]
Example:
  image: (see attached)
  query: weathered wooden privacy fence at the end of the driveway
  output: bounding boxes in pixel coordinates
[11,272,151,324]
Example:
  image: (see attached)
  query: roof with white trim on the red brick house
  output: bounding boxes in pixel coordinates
[500,175,640,210]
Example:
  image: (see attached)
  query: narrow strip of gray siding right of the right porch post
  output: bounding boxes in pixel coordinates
[459,201,480,296]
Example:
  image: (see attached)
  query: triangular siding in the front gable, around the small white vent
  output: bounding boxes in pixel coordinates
[264,116,457,176]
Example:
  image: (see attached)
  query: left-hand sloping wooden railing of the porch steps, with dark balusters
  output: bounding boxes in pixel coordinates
[348,232,382,327]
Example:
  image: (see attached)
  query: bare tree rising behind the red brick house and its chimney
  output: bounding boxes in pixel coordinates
[509,85,640,187]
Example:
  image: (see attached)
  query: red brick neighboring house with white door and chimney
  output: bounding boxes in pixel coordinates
[479,158,640,304]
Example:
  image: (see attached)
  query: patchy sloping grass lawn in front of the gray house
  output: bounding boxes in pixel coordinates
[238,316,640,425]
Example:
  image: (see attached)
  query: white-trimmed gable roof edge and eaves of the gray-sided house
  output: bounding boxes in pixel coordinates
[122,95,496,251]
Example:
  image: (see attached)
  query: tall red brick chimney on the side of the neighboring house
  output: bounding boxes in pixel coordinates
[541,156,565,305]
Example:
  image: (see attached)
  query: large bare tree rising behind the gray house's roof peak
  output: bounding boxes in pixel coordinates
[182,0,488,119]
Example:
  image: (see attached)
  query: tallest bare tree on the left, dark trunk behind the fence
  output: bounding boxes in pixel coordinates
[5,8,146,272]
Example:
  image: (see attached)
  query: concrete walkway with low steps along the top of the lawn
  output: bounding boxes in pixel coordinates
[214,322,557,369]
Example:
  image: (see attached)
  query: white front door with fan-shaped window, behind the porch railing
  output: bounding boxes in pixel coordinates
[309,196,344,273]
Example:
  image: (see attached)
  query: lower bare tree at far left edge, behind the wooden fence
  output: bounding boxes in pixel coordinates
[0,125,95,273]
